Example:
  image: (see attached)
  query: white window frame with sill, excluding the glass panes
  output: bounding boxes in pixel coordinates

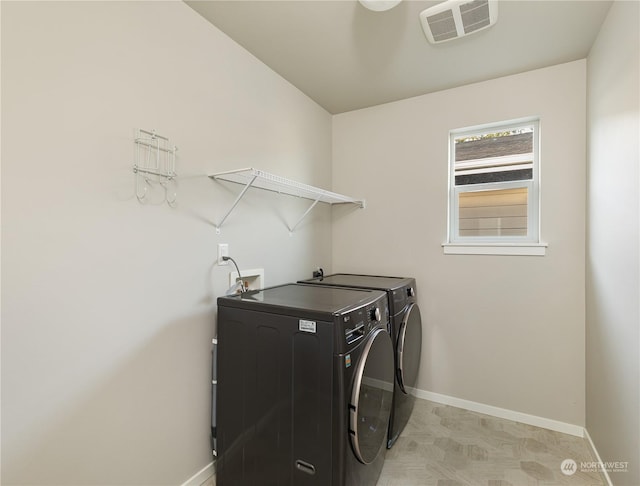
[443,117,547,255]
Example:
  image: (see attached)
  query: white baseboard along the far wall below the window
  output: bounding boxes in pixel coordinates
[414,388,585,437]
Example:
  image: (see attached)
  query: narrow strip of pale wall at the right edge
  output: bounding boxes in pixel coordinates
[586,1,640,486]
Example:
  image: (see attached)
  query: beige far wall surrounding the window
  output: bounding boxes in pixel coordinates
[333,60,586,426]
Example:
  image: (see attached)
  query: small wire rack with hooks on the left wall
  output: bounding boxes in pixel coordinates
[133,128,178,207]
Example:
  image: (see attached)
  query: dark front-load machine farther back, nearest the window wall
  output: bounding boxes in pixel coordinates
[304,273,422,448]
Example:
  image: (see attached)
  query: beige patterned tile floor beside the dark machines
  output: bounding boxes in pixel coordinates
[202,399,606,486]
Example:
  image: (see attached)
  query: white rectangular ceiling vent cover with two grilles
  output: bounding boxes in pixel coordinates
[420,0,498,44]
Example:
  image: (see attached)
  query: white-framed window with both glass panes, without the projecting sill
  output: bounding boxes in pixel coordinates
[445,119,544,254]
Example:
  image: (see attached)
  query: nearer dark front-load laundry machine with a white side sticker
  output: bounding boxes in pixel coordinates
[212,284,394,486]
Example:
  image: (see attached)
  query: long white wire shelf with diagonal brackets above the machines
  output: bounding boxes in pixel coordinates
[209,167,365,233]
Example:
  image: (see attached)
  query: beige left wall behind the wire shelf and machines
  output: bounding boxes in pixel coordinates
[2,2,331,485]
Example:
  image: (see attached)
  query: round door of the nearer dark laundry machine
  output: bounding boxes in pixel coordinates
[349,329,393,464]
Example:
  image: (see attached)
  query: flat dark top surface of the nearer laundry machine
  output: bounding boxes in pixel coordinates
[218,284,386,316]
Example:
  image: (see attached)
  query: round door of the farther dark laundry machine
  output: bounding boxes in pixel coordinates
[396,304,422,393]
